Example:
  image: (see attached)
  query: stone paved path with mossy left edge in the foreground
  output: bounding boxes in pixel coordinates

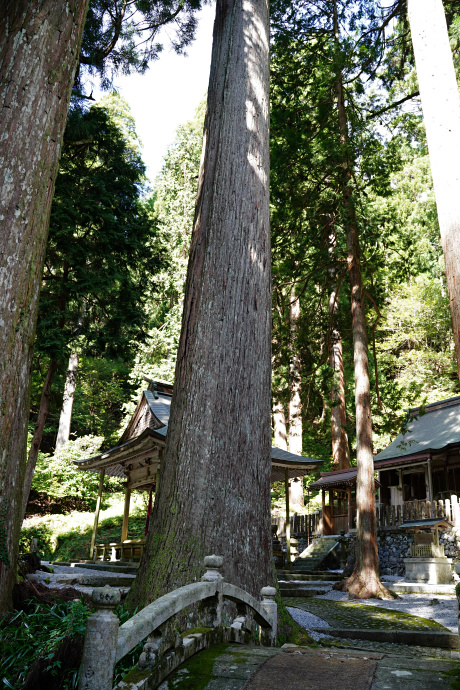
[154,645,460,690]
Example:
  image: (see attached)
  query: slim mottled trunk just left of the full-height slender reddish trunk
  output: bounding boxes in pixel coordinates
[329,276,350,470]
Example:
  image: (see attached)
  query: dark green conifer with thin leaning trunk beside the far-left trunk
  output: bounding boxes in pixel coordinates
[23,103,160,513]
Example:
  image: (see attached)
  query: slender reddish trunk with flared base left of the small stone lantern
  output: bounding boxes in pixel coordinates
[333,0,392,599]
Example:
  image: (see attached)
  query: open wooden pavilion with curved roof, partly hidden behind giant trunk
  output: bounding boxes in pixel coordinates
[74,382,322,561]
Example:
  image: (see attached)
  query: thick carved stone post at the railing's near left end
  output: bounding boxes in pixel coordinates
[78,585,120,690]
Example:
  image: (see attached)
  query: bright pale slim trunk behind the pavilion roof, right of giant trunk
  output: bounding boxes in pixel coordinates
[289,292,303,508]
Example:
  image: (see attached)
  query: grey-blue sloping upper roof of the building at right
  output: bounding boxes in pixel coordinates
[374,396,460,462]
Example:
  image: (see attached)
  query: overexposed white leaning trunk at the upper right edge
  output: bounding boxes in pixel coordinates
[408,0,460,381]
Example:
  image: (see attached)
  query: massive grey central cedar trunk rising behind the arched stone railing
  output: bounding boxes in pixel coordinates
[128,0,273,608]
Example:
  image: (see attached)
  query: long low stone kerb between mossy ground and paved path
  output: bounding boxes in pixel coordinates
[315,628,460,649]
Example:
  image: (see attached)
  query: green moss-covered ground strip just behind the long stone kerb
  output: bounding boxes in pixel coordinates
[284,597,450,632]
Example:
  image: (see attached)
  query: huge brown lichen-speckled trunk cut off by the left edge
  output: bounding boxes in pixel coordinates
[0,0,87,611]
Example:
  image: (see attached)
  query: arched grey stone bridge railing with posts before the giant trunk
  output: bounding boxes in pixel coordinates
[79,556,277,690]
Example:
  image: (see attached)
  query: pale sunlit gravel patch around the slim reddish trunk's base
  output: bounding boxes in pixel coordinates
[316,589,458,633]
